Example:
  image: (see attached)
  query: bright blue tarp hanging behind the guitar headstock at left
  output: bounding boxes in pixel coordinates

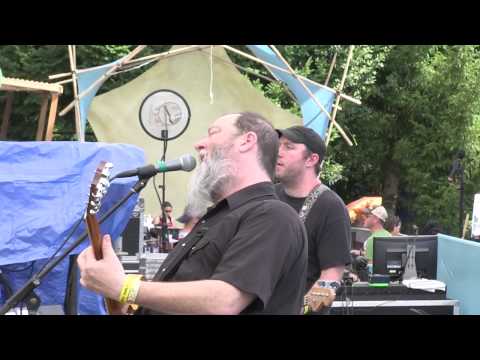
[0,141,145,314]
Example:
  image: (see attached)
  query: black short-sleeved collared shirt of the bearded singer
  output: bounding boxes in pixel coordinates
[142,182,308,314]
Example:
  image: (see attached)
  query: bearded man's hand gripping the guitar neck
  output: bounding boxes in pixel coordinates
[77,235,128,308]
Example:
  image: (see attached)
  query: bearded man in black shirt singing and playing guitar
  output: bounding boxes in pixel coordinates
[78,113,308,314]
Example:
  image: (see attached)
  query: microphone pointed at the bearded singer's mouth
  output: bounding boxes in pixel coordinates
[110,154,197,181]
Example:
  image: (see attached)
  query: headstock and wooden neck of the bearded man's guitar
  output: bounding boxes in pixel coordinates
[85,161,124,314]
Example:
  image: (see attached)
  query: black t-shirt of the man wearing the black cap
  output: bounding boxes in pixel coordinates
[275,184,351,291]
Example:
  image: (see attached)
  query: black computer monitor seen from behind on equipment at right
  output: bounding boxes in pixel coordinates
[373,235,437,281]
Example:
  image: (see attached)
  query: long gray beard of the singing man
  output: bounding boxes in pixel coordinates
[187,146,236,211]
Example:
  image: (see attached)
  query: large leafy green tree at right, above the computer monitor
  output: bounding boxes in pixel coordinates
[335,46,480,232]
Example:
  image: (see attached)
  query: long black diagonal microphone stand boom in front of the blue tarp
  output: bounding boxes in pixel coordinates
[0,178,149,315]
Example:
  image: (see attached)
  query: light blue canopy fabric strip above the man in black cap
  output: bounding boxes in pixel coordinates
[247,45,335,139]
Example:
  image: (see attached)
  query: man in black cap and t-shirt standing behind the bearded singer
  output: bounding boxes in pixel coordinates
[275,126,351,311]
